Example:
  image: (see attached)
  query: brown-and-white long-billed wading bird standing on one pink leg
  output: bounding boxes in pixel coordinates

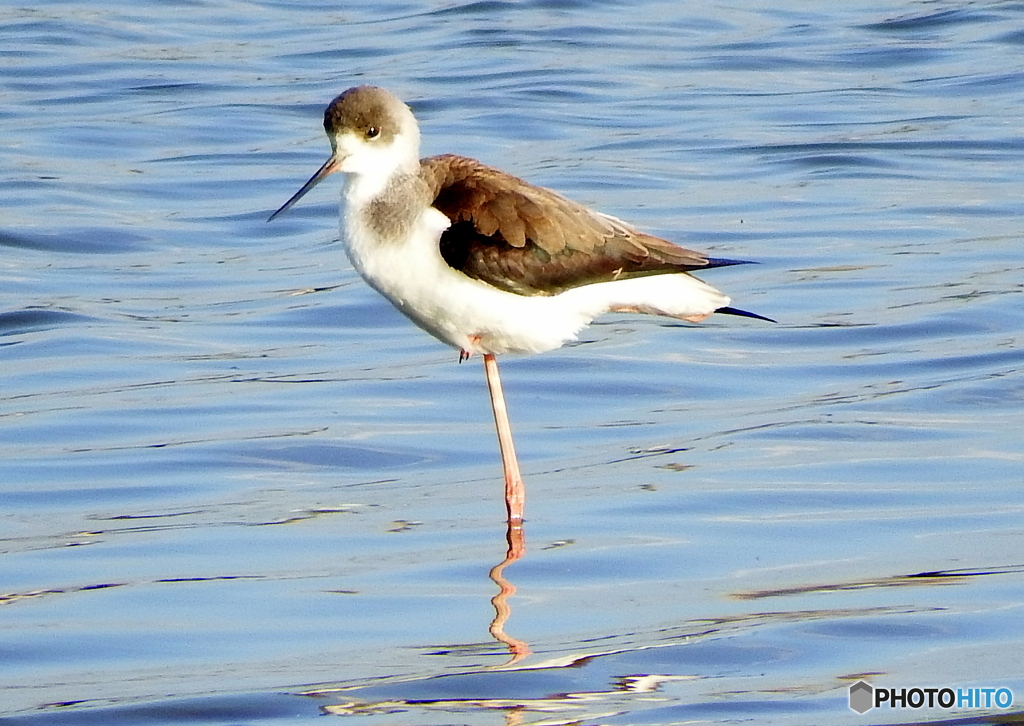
[267,85,773,527]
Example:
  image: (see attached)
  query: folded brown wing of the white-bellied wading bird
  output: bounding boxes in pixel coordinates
[420,155,716,295]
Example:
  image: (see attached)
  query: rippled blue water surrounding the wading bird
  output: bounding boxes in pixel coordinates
[0,0,1024,726]
